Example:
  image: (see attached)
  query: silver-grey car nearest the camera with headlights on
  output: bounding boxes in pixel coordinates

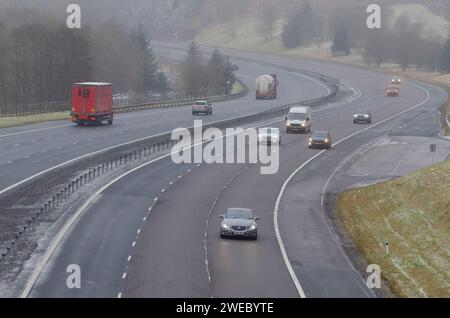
[220,208,259,240]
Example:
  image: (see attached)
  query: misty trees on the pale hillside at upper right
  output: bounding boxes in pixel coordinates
[260,0,450,72]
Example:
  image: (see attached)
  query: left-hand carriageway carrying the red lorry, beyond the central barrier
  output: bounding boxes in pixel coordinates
[0,51,326,194]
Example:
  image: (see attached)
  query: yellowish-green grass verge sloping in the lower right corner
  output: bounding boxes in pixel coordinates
[337,160,450,297]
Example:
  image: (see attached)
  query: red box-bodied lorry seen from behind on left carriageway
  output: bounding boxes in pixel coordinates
[70,82,113,125]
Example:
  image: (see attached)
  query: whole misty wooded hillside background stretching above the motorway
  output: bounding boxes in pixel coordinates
[0,0,450,104]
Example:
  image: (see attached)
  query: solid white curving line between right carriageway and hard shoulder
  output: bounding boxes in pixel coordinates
[273,79,431,298]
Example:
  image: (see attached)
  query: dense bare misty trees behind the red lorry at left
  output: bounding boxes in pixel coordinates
[0,9,169,105]
